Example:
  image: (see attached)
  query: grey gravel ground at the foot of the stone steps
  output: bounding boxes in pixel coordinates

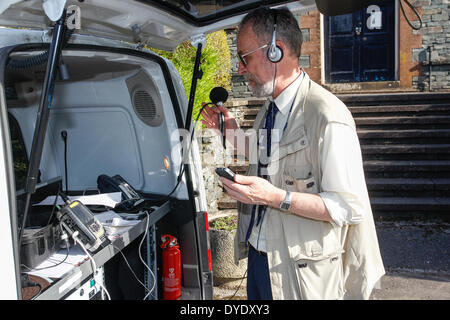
[214,221,450,300]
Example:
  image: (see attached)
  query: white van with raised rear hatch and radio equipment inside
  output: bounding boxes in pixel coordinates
[0,0,315,299]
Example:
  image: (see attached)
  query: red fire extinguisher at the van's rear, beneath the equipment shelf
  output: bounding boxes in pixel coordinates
[161,234,181,300]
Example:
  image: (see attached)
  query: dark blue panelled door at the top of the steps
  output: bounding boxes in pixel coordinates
[324,1,395,83]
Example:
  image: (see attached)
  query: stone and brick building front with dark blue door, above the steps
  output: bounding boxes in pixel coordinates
[227,0,450,98]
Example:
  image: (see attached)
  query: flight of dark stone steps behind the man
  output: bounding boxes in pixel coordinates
[222,93,450,218]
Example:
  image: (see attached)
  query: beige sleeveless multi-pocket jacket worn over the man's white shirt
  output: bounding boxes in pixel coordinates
[235,74,384,299]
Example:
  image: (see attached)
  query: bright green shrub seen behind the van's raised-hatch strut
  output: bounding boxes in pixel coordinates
[152,30,231,125]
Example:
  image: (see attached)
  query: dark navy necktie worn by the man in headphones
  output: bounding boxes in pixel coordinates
[245,102,278,243]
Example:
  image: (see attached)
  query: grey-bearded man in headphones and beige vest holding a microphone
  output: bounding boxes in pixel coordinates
[202,7,384,299]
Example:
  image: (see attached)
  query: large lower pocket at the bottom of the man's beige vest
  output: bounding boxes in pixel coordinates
[293,253,344,300]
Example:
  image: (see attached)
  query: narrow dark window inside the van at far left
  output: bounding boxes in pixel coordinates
[8,113,28,190]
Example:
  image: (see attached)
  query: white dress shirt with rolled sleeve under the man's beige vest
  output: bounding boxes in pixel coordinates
[249,72,370,252]
